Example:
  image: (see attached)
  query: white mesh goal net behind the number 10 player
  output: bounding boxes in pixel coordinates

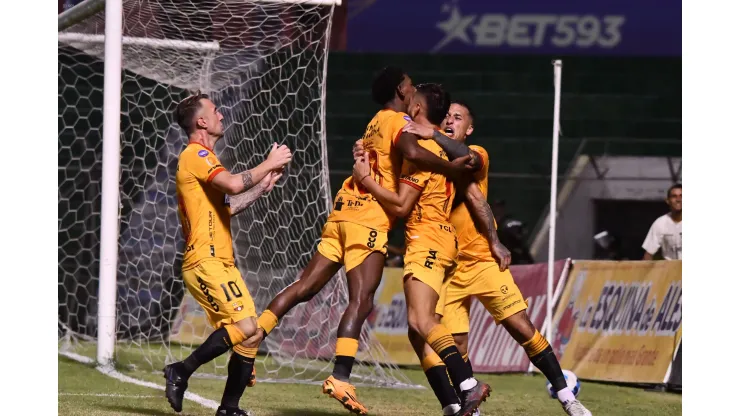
[58,0,411,386]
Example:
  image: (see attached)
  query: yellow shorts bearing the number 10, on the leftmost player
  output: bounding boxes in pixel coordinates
[182,260,257,329]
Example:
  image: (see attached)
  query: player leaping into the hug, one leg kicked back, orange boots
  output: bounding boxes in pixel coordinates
[250,67,471,414]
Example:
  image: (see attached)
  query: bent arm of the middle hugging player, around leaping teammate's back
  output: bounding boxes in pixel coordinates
[352,153,422,217]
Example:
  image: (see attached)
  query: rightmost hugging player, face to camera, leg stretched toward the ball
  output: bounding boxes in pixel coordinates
[404,101,591,416]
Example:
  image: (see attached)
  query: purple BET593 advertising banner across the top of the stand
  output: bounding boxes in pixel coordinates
[347,0,681,56]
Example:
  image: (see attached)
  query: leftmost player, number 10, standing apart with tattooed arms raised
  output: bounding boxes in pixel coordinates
[164,93,292,416]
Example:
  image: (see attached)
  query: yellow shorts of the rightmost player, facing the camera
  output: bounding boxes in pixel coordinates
[436,260,527,334]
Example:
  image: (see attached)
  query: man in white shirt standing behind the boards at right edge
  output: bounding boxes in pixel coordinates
[642,184,681,260]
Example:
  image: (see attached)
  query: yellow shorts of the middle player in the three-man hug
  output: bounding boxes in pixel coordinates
[403,243,456,299]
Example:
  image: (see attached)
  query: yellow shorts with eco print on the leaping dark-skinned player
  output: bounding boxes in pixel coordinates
[318,221,388,271]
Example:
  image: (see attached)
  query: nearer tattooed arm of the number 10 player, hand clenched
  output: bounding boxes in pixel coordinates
[210,143,293,195]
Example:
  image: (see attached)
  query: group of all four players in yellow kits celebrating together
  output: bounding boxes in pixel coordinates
[164,67,591,416]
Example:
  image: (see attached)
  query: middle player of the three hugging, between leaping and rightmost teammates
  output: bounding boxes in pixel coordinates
[353,84,490,416]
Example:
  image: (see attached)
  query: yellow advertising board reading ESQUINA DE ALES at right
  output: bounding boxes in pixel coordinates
[553,261,681,383]
